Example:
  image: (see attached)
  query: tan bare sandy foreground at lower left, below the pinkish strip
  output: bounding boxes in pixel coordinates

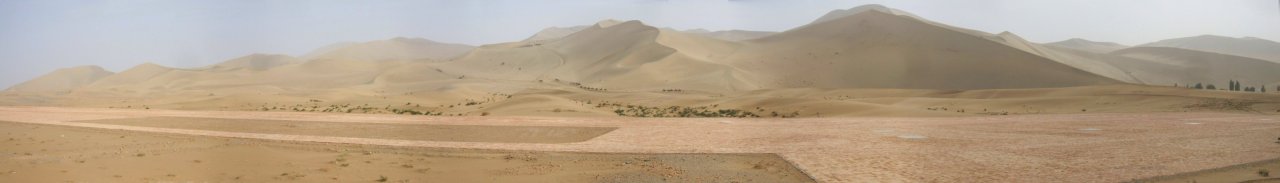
[0,117,813,183]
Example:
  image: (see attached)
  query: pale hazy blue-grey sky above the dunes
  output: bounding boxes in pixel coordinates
[0,0,1280,88]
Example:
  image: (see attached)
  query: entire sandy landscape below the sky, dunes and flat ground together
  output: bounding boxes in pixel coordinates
[0,5,1280,182]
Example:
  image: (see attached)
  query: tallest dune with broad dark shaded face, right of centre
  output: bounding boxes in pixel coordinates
[728,6,1120,90]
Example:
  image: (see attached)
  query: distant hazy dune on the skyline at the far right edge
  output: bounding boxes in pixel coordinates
[1138,35,1280,63]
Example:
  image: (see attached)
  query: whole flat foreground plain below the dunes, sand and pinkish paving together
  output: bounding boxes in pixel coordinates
[0,106,1280,182]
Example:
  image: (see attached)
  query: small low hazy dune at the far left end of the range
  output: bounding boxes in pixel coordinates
[8,65,115,92]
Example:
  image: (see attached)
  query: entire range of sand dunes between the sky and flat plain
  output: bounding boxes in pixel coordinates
[0,5,1280,118]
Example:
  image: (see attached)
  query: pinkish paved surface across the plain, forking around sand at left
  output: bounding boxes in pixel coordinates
[0,107,1280,182]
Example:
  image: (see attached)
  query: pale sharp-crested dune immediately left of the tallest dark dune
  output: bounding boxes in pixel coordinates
[440,20,746,91]
